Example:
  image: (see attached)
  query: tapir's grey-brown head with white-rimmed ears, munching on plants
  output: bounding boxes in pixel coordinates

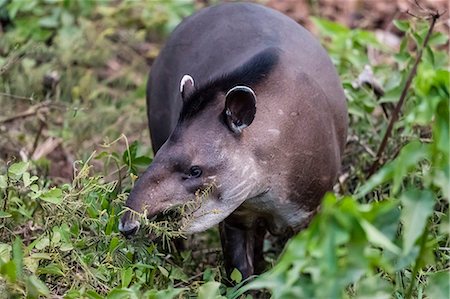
[119,75,258,235]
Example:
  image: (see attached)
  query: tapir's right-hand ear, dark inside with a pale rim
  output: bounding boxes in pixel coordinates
[224,86,256,134]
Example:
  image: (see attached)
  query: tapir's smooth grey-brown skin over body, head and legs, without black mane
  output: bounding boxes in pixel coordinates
[119,3,347,278]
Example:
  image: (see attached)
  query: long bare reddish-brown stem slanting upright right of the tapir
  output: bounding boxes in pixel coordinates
[367,12,442,177]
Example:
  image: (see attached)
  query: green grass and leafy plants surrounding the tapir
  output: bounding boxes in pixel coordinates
[0,0,450,299]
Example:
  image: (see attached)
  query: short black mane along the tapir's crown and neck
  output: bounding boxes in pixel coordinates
[179,48,279,121]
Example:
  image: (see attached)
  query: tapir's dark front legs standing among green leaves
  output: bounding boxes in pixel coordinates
[219,219,265,279]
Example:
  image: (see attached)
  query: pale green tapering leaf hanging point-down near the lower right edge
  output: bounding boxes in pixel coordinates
[400,190,435,254]
